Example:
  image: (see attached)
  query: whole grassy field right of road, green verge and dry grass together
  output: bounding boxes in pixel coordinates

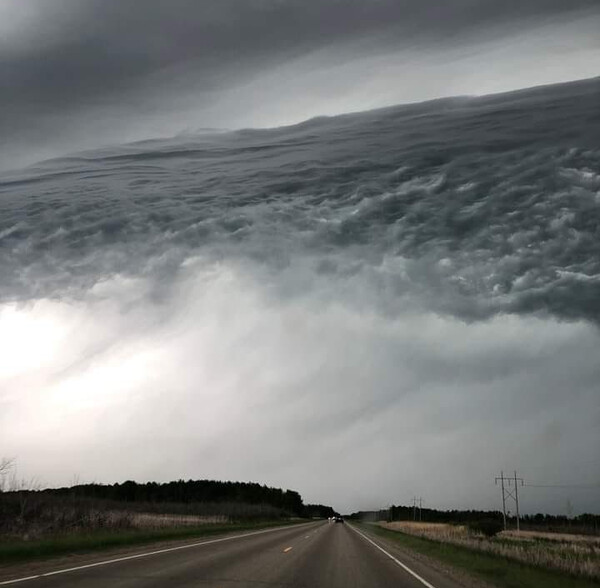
[360,522,600,588]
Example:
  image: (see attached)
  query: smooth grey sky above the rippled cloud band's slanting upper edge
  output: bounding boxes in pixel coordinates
[0,0,600,169]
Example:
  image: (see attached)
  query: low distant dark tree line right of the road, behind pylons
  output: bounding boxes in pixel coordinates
[349,506,600,533]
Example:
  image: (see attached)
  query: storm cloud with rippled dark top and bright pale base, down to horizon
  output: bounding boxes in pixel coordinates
[0,71,600,512]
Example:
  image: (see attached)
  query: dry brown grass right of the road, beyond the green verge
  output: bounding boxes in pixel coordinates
[380,521,600,580]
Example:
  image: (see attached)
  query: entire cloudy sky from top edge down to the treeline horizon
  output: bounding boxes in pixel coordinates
[0,0,600,514]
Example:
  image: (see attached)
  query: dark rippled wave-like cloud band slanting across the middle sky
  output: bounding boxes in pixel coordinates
[0,80,600,322]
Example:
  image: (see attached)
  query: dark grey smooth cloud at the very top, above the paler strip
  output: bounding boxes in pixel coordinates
[0,0,595,170]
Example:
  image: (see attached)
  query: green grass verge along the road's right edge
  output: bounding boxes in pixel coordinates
[358,524,598,588]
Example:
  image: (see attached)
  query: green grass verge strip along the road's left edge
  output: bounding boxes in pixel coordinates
[0,521,304,566]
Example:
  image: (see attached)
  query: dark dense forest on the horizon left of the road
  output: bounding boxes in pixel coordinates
[32,480,335,517]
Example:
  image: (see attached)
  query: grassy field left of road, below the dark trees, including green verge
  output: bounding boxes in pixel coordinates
[0,491,308,566]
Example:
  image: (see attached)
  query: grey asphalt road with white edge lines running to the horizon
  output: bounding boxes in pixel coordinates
[0,522,460,588]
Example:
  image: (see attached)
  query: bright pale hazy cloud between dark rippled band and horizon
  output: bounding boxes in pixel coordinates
[0,259,600,511]
